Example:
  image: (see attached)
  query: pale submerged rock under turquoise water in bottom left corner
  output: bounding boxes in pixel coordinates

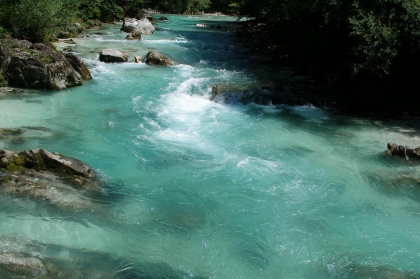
[0,236,203,279]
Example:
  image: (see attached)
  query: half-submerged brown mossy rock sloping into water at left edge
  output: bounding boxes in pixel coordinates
[0,149,100,211]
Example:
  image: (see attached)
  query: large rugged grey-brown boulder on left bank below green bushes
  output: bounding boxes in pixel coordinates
[0,39,90,90]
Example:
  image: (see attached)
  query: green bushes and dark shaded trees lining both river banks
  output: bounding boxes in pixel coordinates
[0,0,420,114]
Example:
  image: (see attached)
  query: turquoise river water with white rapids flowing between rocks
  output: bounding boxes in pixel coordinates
[0,15,420,278]
